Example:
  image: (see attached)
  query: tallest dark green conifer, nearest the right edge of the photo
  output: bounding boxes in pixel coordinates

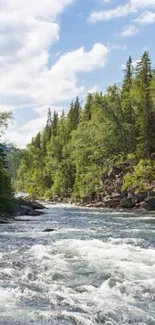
[136,52,155,158]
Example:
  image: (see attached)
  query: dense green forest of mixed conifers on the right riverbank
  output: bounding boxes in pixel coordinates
[13,52,155,205]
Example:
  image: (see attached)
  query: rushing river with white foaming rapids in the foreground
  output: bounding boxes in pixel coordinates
[0,206,155,325]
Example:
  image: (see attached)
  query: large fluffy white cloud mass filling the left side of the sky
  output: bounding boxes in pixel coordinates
[0,0,109,146]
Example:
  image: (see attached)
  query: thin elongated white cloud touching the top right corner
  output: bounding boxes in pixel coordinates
[89,0,155,23]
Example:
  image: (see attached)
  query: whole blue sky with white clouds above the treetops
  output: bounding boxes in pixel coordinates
[0,0,155,148]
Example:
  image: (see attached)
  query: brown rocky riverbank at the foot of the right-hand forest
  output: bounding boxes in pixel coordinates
[43,162,155,211]
